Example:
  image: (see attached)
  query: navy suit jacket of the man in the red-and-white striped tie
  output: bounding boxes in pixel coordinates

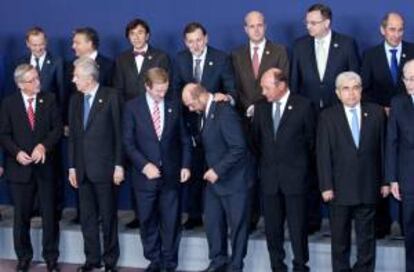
[123,93,191,190]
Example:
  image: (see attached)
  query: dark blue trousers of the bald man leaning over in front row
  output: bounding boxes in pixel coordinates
[204,187,249,271]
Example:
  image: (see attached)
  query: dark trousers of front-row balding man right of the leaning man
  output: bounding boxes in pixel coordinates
[263,192,309,272]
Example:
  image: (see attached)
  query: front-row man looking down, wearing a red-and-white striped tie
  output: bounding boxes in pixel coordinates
[124,67,191,272]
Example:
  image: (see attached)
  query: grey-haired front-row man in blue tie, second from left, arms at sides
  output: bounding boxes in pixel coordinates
[68,57,124,272]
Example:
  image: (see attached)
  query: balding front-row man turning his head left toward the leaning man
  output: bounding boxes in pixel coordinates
[252,68,316,271]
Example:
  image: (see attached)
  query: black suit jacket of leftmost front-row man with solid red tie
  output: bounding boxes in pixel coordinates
[0,91,63,183]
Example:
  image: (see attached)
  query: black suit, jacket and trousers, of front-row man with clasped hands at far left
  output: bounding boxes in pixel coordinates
[0,92,63,262]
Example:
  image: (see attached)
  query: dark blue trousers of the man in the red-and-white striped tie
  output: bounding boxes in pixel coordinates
[134,180,180,269]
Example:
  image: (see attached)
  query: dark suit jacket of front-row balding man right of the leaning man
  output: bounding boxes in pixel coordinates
[253,94,316,194]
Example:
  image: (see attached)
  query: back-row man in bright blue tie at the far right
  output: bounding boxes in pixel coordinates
[361,12,414,238]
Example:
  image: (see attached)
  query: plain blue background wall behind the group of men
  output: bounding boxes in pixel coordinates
[0,0,414,206]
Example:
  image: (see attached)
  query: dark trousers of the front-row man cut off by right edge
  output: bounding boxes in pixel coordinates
[402,194,414,272]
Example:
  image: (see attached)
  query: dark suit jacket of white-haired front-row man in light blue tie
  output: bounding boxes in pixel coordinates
[316,103,386,205]
